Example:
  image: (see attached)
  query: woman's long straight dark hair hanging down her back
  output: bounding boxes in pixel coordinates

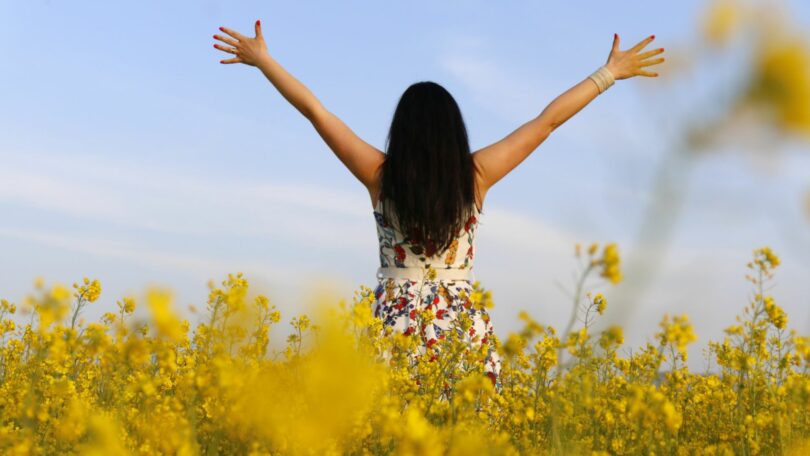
[380,81,476,257]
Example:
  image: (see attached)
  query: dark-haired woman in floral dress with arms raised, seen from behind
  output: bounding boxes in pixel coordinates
[214,21,664,388]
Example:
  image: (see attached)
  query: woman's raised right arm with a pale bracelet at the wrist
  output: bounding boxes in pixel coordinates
[473,34,664,192]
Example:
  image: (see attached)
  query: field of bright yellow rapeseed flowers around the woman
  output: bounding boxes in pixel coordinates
[0,244,810,455]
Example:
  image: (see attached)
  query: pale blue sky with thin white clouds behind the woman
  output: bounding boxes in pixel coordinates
[0,0,810,367]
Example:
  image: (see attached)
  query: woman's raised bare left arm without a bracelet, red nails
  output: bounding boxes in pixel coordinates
[214,21,385,191]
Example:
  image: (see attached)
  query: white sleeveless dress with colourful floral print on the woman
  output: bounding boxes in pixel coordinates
[372,196,501,390]
